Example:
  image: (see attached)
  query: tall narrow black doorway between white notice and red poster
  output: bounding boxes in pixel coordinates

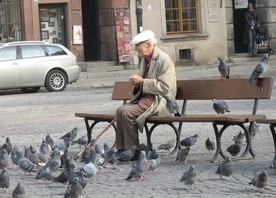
[81,0,101,61]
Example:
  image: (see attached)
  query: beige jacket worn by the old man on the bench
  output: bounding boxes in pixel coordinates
[130,46,177,133]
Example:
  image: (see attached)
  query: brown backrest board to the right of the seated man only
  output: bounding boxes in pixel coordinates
[176,78,273,100]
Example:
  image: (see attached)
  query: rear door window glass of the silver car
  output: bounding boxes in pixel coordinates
[21,45,46,58]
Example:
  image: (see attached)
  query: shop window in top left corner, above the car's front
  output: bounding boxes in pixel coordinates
[0,0,22,43]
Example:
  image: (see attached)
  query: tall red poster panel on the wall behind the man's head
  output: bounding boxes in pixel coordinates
[115,8,133,62]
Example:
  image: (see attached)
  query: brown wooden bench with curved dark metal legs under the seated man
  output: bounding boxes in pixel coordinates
[75,78,273,162]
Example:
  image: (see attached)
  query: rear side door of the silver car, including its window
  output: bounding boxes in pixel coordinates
[20,45,51,86]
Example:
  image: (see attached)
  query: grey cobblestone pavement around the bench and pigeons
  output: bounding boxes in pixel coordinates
[0,61,276,198]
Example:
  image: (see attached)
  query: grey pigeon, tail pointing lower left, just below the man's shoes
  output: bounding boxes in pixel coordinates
[126,151,150,181]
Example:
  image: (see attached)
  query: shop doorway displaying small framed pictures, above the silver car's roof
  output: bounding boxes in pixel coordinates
[39,4,68,47]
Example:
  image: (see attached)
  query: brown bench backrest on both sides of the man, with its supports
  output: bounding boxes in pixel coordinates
[112,78,273,114]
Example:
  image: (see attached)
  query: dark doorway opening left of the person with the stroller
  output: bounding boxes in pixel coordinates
[233,0,256,54]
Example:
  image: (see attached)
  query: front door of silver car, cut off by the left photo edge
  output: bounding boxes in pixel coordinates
[0,46,20,89]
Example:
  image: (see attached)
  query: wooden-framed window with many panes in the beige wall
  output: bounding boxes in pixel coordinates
[165,0,199,34]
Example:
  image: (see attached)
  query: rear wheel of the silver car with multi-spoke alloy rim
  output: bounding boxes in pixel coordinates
[45,70,67,92]
